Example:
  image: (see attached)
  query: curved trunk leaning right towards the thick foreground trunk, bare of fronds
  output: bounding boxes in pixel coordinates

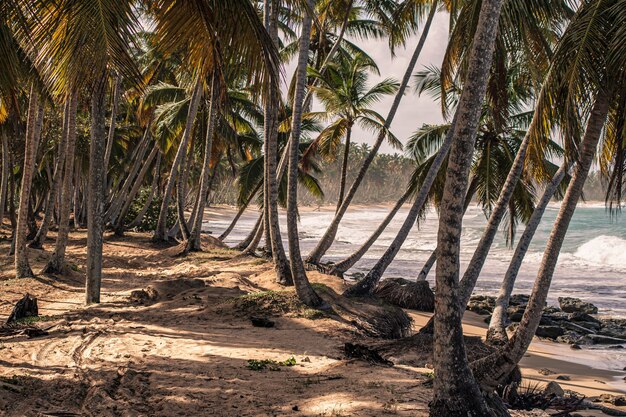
[344,115,456,297]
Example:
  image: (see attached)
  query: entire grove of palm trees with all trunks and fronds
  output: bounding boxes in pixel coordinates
[0,0,626,417]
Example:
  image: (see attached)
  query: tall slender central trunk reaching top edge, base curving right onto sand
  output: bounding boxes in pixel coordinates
[287,0,323,307]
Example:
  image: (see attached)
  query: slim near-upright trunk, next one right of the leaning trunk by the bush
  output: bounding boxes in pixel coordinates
[185,72,220,252]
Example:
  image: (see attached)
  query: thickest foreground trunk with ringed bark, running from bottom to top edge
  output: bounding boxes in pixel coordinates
[430,0,504,417]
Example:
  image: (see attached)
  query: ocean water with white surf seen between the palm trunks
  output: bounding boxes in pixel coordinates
[207,203,626,317]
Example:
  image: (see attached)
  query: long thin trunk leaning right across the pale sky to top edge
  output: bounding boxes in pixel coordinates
[306,0,438,264]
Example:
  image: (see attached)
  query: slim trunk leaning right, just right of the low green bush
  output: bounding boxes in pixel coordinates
[152,76,202,242]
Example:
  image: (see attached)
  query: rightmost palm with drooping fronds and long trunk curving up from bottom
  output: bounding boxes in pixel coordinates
[473,0,626,387]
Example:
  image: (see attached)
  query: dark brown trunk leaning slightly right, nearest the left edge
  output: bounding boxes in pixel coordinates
[14,84,43,278]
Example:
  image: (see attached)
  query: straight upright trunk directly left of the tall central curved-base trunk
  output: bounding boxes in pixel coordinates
[264,1,293,285]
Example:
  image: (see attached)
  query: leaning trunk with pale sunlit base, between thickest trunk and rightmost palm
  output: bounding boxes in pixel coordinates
[487,162,569,344]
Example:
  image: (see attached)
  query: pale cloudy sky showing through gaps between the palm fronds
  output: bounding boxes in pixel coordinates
[286,13,448,153]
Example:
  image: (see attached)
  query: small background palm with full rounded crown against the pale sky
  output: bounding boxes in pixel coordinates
[310,54,402,210]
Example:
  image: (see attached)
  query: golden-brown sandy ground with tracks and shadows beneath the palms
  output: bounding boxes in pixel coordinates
[0,231,624,416]
